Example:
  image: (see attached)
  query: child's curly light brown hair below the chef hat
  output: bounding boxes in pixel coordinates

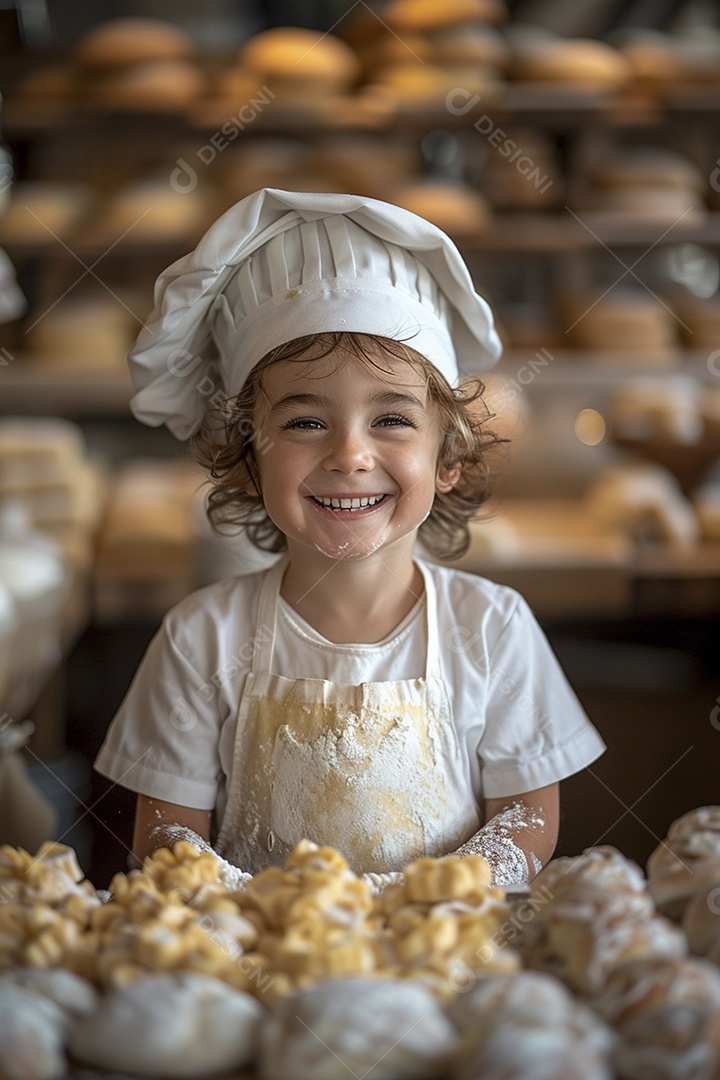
[191,332,507,558]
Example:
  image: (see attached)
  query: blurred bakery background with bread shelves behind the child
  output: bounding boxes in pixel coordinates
[0,0,720,886]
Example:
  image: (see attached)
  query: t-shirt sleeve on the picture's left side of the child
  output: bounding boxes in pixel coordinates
[95,619,222,810]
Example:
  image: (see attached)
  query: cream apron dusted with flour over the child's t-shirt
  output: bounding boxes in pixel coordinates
[216,559,480,874]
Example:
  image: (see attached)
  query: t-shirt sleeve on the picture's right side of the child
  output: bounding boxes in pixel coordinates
[477,596,606,798]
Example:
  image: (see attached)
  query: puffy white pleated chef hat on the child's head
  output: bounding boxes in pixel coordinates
[128,188,501,438]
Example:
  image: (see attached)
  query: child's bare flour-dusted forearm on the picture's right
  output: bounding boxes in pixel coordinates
[456,784,560,886]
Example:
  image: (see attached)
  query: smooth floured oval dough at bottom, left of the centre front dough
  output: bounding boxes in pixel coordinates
[68,974,263,1077]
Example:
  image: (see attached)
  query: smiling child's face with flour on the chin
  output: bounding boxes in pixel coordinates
[250,345,452,559]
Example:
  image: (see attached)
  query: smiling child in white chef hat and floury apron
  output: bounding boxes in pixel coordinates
[96,189,604,886]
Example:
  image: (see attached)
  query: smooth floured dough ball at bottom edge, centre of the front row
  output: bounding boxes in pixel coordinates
[259,977,458,1080]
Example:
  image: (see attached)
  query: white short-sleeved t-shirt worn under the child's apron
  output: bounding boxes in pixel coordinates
[95,563,604,822]
